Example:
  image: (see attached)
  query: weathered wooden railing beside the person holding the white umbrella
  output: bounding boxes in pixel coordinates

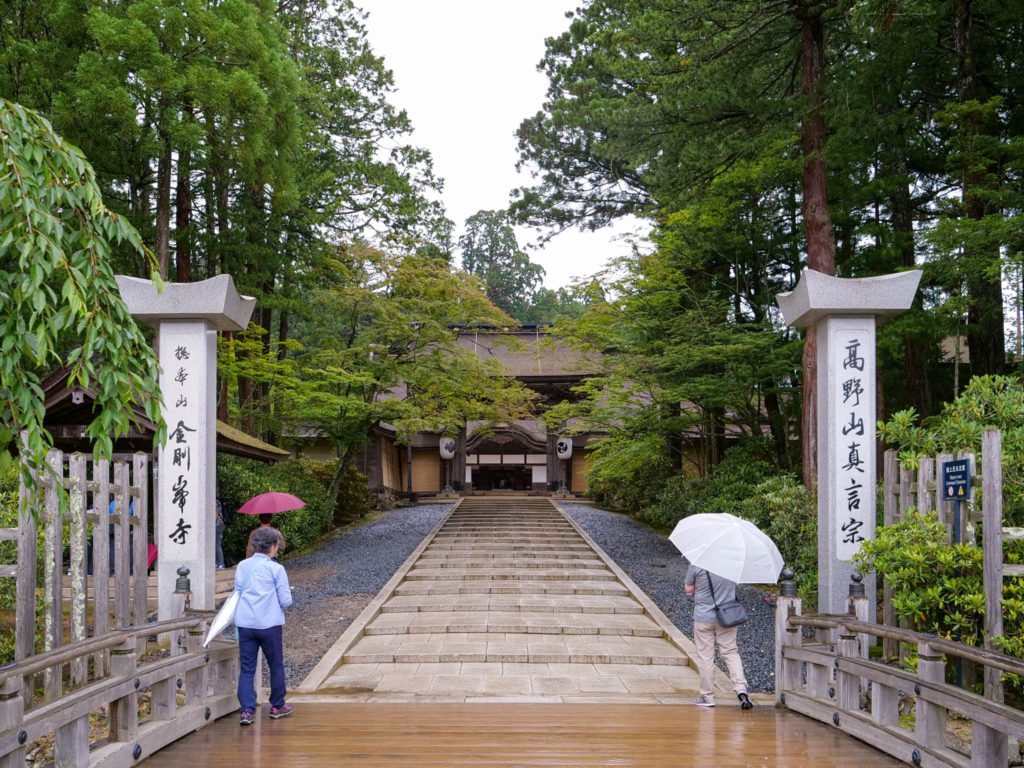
[775,570,1024,768]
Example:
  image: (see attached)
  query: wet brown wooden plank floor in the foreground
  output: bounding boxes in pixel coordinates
[144,701,902,768]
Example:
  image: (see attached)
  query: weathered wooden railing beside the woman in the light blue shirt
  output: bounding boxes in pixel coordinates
[0,585,239,768]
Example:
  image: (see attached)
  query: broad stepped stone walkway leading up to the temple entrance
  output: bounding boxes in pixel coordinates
[295,497,716,703]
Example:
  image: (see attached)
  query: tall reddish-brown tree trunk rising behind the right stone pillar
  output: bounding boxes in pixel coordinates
[797,4,836,490]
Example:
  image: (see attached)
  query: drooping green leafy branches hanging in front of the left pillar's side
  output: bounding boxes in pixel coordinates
[0,100,163,484]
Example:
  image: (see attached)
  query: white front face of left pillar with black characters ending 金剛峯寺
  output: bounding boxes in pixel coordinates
[158,326,206,561]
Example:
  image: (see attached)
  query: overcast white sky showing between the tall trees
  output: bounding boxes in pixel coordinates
[356,0,635,288]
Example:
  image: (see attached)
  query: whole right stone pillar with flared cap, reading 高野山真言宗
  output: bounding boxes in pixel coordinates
[777,269,922,621]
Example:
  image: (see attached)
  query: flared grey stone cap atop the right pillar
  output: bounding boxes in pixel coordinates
[775,269,923,328]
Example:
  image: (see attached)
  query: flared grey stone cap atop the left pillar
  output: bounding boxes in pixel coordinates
[115,274,256,331]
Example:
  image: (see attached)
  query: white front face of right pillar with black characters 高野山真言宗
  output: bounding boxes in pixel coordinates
[820,318,876,560]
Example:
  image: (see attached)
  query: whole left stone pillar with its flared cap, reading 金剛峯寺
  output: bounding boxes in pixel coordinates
[117,274,256,621]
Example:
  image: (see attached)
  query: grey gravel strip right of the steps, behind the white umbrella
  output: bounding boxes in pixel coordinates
[560,502,775,692]
